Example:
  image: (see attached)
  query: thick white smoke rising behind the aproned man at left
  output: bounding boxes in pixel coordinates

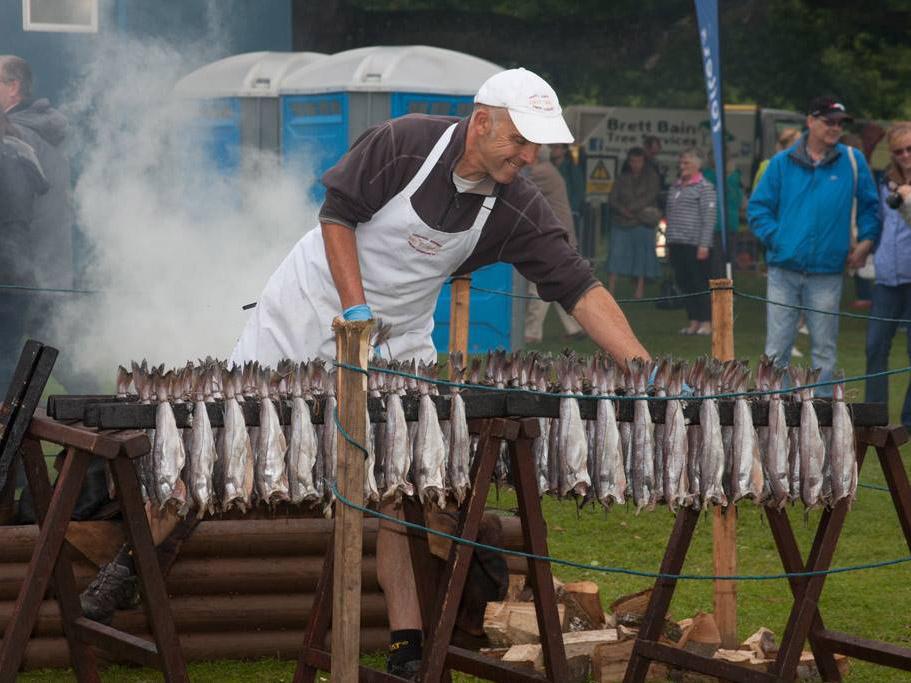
[54,29,316,388]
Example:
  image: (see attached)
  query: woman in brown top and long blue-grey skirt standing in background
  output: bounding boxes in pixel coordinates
[607,147,661,299]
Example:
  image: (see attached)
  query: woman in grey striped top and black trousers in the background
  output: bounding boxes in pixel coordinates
[666,149,718,335]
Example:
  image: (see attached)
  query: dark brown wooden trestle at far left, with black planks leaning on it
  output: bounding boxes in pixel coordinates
[0,341,187,683]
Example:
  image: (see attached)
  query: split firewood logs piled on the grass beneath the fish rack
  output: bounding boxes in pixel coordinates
[484,575,848,683]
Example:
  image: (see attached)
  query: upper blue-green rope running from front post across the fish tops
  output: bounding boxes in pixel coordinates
[333,361,911,401]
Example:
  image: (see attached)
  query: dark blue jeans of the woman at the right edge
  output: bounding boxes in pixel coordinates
[864,284,911,427]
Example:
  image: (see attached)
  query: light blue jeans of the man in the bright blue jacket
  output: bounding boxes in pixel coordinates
[765,266,842,396]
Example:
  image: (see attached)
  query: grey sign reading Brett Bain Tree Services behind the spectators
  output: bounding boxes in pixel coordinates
[578,107,756,201]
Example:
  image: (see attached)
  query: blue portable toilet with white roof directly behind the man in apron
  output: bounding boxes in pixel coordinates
[281,45,526,353]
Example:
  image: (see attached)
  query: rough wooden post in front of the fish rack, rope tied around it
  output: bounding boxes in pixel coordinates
[326,318,373,683]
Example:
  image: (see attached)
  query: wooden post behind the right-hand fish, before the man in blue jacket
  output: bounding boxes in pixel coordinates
[709,279,738,649]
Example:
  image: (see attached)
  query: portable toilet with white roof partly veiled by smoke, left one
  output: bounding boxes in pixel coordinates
[174,52,326,174]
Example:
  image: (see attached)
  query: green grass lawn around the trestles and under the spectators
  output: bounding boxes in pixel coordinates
[21,274,911,683]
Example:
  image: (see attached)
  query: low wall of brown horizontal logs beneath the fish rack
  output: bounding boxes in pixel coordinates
[0,516,525,670]
